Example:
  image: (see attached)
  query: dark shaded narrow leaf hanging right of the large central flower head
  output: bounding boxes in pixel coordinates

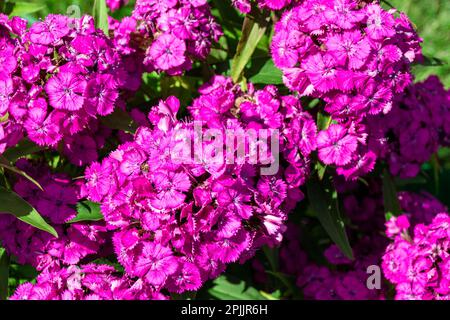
[307,178,353,260]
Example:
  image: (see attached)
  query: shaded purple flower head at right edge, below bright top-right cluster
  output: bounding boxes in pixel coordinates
[369,76,450,178]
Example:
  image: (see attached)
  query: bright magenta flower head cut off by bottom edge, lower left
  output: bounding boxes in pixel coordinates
[10,263,166,300]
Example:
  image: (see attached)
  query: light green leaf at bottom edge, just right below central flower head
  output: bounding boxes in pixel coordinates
[208,276,267,300]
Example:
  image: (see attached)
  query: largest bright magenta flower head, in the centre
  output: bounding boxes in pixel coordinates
[83,77,315,293]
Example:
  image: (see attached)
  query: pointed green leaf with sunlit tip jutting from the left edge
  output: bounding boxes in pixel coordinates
[0,187,58,237]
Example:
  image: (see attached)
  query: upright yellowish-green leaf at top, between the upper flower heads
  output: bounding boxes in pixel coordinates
[231,10,270,83]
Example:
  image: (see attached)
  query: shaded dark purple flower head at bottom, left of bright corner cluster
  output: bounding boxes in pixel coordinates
[253,224,386,300]
